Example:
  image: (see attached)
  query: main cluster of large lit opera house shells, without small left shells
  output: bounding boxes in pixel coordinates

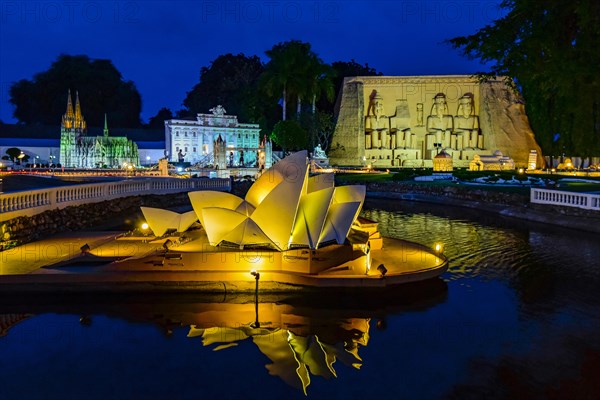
[186,151,365,250]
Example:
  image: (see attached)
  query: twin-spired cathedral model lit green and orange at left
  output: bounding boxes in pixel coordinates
[60,91,139,168]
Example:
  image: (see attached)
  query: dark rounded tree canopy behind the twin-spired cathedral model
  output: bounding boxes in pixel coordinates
[9,55,142,128]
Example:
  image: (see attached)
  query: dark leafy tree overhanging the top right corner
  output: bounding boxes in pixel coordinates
[449,0,600,156]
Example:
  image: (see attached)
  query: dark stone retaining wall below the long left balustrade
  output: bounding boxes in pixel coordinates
[0,193,189,250]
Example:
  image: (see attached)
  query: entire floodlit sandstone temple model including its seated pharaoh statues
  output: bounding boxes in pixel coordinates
[329,76,542,167]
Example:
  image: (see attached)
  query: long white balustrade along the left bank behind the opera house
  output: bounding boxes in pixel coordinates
[0,178,231,221]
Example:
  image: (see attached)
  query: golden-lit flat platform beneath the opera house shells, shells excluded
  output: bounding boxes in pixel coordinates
[0,229,447,293]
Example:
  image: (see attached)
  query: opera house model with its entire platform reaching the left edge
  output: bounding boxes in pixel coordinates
[0,151,447,294]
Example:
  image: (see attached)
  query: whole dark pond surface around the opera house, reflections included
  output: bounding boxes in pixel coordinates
[0,201,600,399]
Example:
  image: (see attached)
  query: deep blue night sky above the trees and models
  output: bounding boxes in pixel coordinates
[0,0,501,122]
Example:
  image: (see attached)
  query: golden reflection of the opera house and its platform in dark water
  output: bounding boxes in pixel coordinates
[0,279,447,394]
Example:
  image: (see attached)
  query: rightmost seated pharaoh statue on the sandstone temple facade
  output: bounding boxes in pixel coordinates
[454,93,483,150]
